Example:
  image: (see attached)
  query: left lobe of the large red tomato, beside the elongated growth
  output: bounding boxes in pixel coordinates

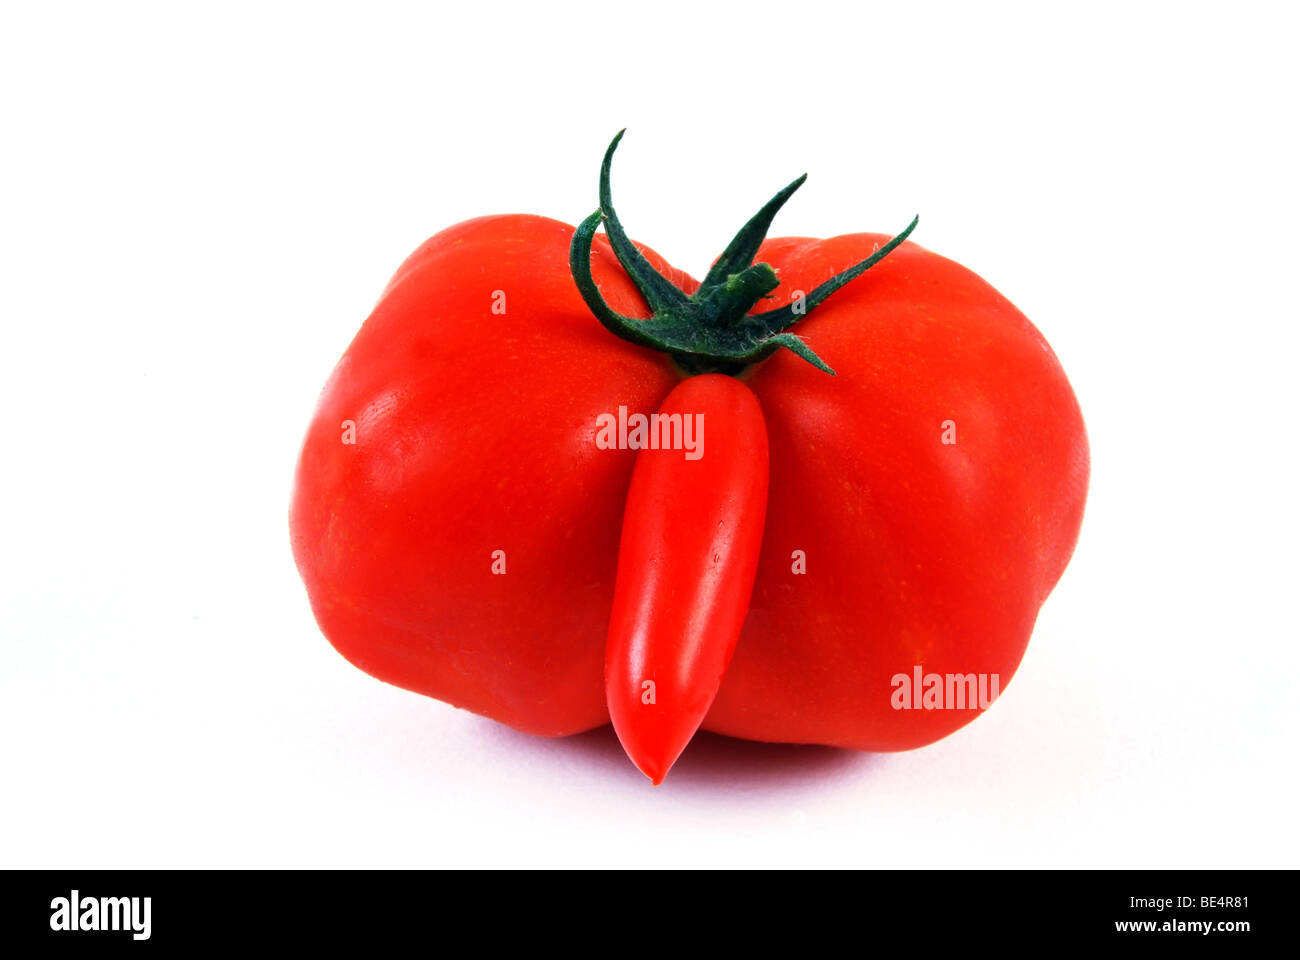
[290,216,689,736]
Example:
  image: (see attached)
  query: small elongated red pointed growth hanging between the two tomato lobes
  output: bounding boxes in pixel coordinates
[605,373,768,784]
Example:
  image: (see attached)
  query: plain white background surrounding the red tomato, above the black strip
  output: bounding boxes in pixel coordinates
[0,0,1300,868]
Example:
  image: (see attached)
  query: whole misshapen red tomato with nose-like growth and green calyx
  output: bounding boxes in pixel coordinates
[290,134,1088,778]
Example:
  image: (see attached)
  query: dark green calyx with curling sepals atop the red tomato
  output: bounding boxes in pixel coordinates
[569,130,919,376]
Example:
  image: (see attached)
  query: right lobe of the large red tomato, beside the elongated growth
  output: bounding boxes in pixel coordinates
[705,233,1089,751]
